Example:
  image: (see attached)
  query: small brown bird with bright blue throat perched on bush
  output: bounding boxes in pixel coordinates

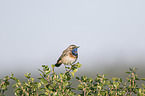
[55,45,79,67]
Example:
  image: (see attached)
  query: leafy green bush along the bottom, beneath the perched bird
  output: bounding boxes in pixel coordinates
[0,63,145,96]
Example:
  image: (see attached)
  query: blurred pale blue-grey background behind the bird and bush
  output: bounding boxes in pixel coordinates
[0,0,145,96]
